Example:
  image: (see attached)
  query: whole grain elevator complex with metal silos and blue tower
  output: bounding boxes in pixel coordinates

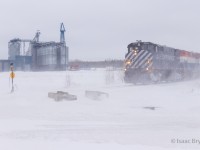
[0,23,69,71]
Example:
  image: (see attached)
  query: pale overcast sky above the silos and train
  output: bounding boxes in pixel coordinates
[0,0,200,60]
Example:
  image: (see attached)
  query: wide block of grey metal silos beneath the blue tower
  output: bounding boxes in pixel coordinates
[32,42,68,71]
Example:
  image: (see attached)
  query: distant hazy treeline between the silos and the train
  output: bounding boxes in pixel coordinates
[69,60,123,69]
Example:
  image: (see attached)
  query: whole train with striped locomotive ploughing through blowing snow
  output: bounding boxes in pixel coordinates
[124,41,200,83]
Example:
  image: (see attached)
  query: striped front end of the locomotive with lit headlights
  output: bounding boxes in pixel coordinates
[124,42,155,82]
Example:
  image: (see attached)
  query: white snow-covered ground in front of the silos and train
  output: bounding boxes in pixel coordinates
[0,69,200,150]
